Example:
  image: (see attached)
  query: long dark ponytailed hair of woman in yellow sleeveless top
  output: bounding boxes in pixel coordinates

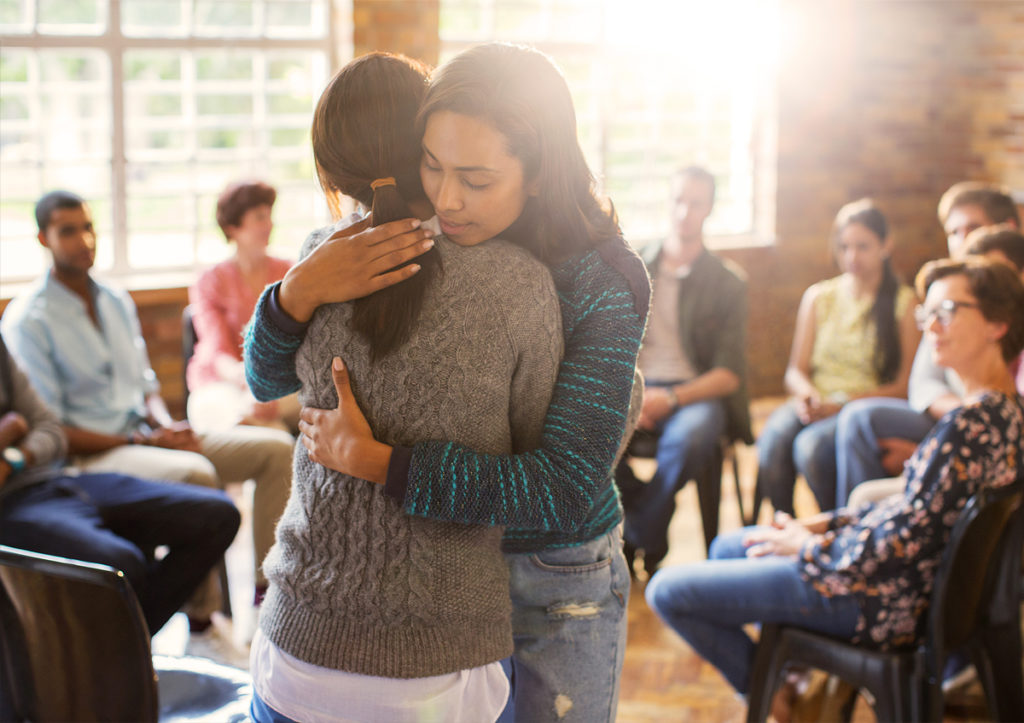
[831,199,903,383]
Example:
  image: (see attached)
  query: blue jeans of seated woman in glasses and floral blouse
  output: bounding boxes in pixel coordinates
[646,527,860,695]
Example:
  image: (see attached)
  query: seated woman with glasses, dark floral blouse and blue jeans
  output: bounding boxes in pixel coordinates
[646,259,1024,720]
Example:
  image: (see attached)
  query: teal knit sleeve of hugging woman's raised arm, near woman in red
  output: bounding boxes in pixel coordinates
[243,282,309,401]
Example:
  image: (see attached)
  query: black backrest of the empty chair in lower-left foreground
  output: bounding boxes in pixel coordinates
[0,546,158,721]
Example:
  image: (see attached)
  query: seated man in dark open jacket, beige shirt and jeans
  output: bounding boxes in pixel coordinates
[615,167,754,573]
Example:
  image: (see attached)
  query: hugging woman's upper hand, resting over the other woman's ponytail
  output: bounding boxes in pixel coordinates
[281,218,434,322]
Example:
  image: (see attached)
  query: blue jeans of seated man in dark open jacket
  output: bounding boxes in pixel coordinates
[624,399,726,560]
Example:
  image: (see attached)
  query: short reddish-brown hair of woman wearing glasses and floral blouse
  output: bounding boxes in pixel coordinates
[916,257,1024,362]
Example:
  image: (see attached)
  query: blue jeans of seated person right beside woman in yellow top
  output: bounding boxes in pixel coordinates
[836,396,935,507]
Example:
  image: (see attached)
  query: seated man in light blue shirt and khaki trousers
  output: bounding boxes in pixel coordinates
[0,190,293,612]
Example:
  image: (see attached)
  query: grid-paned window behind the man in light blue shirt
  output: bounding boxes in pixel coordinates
[0,0,337,296]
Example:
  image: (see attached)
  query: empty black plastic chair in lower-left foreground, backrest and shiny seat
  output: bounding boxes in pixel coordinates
[0,546,252,722]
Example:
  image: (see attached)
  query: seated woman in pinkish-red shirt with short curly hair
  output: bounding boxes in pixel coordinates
[186,181,299,434]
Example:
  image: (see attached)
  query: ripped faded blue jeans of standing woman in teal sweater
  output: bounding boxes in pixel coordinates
[506,527,630,723]
